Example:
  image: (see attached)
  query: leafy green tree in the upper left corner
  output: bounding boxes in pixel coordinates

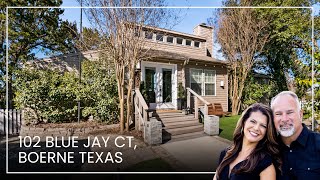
[0,0,77,108]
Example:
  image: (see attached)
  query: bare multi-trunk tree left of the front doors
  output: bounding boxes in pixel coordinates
[80,0,175,133]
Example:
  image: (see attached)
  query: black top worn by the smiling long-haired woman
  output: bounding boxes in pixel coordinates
[219,149,272,180]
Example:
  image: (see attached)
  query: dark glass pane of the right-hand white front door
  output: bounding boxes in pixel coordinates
[162,69,172,102]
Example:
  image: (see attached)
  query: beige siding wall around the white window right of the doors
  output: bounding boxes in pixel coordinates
[185,64,228,112]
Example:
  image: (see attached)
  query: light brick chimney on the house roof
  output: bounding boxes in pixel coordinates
[193,23,213,57]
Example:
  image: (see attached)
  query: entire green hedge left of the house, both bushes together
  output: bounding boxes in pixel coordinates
[14,61,118,123]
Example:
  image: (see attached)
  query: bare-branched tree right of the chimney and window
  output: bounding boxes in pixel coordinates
[212,1,269,115]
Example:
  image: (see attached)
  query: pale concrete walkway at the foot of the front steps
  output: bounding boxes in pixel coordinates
[161,136,231,172]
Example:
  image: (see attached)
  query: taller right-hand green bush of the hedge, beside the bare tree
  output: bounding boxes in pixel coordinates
[79,61,119,123]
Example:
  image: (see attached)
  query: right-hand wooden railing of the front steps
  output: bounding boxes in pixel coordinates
[186,88,211,118]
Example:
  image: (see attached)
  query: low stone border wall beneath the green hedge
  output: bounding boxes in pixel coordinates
[20,124,119,136]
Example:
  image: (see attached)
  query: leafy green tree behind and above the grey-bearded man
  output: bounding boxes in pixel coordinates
[219,0,320,119]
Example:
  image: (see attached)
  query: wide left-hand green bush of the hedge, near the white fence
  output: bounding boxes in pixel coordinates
[14,68,79,122]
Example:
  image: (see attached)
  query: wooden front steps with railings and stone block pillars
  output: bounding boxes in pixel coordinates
[134,88,219,145]
